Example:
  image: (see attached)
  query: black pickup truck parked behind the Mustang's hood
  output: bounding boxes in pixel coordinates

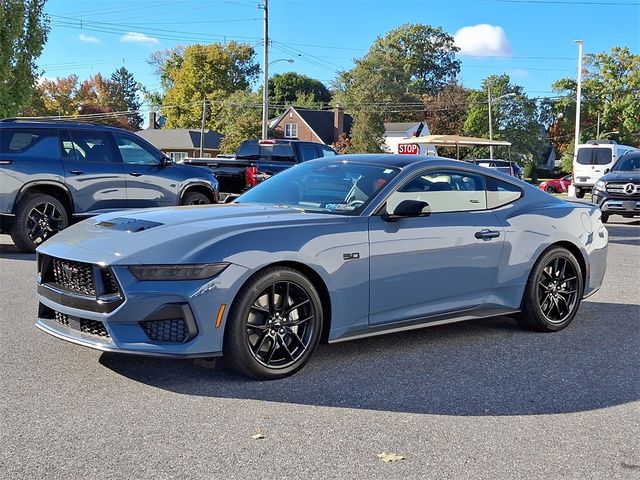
[184,140,337,201]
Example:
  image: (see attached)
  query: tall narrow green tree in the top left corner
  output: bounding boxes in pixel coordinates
[0,0,49,118]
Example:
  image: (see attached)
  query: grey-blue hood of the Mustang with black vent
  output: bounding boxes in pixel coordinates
[38,204,349,265]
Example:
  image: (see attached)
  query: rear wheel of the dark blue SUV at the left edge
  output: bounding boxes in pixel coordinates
[9,193,69,252]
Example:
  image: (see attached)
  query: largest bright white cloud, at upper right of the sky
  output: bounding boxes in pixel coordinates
[453,23,511,57]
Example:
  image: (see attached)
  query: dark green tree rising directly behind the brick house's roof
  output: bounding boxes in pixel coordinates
[269,72,331,110]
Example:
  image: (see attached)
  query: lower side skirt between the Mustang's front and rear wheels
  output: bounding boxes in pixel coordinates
[327,308,520,343]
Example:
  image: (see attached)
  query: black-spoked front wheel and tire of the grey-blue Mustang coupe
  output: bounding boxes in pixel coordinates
[223,267,323,380]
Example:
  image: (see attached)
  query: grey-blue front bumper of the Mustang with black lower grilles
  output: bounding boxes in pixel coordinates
[36,258,247,358]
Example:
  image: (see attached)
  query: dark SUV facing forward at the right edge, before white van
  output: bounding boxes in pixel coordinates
[591,151,640,223]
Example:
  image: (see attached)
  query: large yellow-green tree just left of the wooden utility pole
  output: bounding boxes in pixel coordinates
[162,42,260,128]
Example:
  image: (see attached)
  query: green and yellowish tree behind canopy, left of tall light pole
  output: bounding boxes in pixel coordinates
[464,75,547,163]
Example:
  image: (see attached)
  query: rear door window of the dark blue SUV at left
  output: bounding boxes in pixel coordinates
[67,130,118,163]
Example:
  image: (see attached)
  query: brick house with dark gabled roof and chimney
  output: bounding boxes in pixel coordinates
[269,105,353,145]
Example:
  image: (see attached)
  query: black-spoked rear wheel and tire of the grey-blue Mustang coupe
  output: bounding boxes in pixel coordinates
[516,247,584,332]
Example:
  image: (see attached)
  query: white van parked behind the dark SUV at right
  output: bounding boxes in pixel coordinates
[573,140,637,198]
